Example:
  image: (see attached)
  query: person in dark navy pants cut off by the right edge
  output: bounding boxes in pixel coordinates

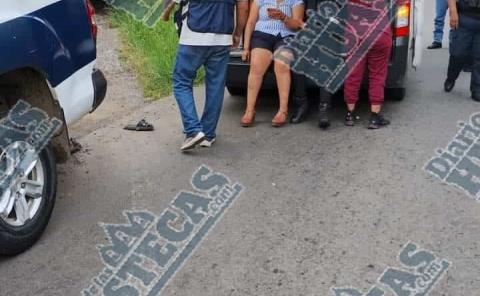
[444,0,480,102]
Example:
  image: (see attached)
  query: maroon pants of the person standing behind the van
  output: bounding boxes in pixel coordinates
[344,27,392,105]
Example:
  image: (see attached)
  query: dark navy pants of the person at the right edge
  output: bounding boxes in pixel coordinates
[447,14,480,94]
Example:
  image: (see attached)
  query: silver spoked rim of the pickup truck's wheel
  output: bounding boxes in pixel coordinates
[0,142,45,227]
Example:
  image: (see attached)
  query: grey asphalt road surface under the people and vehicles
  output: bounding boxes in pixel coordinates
[0,3,480,296]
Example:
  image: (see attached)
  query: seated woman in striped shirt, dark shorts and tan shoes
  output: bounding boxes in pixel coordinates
[241,0,305,127]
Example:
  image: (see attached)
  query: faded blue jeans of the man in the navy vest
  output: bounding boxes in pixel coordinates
[173,45,230,139]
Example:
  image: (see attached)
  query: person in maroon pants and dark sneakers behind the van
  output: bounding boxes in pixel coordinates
[344,26,392,129]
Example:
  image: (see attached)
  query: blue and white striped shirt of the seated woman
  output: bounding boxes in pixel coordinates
[255,0,304,37]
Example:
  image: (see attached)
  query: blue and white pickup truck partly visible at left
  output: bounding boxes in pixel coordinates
[0,0,107,255]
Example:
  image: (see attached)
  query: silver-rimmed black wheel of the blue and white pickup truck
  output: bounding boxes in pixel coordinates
[0,142,57,256]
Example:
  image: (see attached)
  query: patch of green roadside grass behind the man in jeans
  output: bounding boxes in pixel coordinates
[109,9,204,99]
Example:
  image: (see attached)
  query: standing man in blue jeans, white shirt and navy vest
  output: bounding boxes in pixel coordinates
[173,0,249,151]
